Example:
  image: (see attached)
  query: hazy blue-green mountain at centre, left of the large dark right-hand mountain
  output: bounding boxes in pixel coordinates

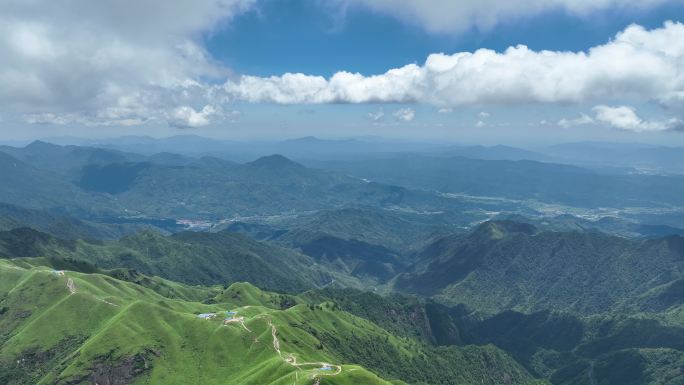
[227,207,456,282]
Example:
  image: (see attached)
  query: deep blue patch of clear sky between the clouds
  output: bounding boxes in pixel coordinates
[206,0,684,76]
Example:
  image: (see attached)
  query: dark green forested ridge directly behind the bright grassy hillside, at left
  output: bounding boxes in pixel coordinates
[0,228,344,291]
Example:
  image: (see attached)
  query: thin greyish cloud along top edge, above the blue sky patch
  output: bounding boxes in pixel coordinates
[337,0,674,33]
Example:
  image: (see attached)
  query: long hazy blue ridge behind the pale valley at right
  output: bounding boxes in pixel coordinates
[310,155,684,207]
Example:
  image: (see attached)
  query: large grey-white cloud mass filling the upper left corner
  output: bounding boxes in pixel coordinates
[0,0,256,124]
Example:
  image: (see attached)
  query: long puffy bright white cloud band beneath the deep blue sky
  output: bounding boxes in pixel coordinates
[222,22,684,114]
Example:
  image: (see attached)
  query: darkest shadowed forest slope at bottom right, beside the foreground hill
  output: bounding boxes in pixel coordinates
[306,289,684,385]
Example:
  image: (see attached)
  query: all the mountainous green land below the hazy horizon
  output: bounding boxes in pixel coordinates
[0,142,684,385]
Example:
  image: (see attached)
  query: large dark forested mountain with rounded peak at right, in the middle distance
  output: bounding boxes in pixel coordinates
[394,221,684,314]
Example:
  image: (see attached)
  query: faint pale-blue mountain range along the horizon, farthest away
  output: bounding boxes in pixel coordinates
[36,135,684,174]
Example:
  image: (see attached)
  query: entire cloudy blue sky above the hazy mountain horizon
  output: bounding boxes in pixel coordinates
[0,0,684,145]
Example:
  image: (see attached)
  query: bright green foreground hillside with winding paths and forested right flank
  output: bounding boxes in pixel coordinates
[0,260,538,385]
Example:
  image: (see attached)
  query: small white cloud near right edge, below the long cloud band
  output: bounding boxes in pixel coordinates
[594,105,683,132]
